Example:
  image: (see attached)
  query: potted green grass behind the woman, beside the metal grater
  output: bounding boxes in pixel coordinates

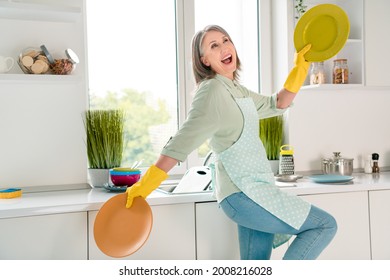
[259,115,283,175]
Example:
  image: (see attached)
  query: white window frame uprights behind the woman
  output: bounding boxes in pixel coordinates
[170,0,272,175]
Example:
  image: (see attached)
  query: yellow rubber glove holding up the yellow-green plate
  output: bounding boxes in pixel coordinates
[284,44,311,93]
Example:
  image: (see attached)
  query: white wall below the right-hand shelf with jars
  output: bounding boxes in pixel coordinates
[288,88,390,171]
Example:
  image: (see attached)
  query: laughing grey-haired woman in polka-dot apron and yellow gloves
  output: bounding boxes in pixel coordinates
[126,25,337,259]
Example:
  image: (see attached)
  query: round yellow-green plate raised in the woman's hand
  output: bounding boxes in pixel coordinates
[294,4,350,62]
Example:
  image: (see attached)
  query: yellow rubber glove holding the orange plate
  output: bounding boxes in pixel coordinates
[126,165,168,208]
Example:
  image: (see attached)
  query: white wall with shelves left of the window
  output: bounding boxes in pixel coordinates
[0,0,88,187]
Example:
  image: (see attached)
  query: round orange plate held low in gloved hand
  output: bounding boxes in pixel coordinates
[93,193,153,258]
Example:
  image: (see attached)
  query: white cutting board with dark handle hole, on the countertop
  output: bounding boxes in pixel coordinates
[172,166,211,193]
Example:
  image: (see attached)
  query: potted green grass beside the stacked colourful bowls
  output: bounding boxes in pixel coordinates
[84,110,125,187]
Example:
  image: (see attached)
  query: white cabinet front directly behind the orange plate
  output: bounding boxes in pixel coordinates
[88,203,195,260]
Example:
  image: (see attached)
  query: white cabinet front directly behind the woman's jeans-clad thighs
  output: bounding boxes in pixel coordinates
[196,202,287,260]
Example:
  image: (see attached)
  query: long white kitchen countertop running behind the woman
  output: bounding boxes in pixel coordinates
[0,172,390,219]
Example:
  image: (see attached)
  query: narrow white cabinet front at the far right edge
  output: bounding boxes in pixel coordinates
[369,190,390,260]
